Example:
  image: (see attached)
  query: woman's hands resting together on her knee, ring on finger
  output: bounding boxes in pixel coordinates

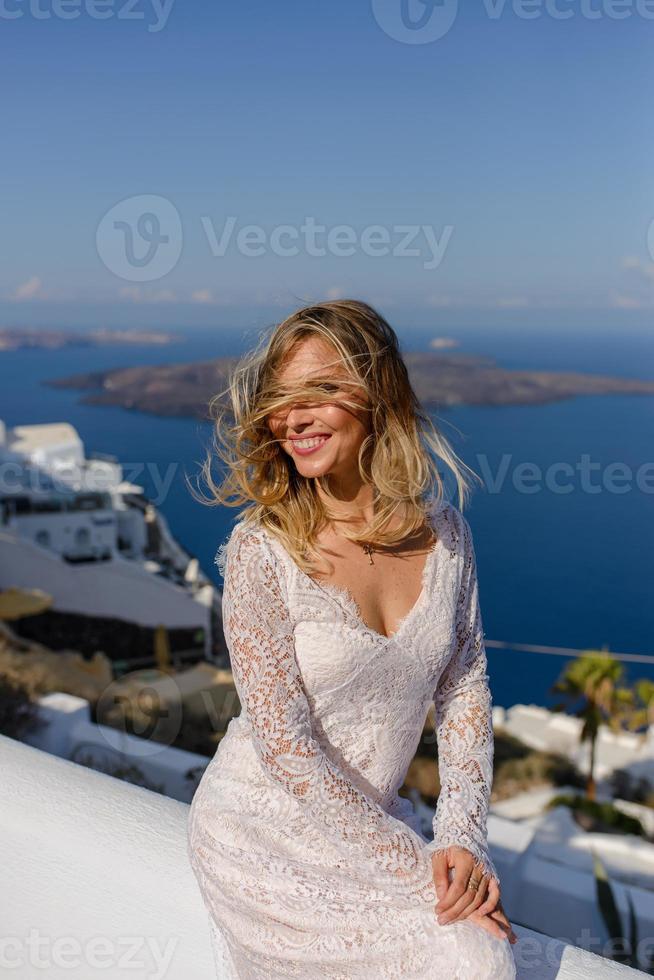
[432,845,517,942]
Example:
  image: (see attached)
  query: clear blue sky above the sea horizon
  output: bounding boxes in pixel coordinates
[0,0,654,331]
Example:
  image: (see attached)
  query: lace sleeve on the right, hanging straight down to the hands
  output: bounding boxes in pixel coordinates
[428,514,499,883]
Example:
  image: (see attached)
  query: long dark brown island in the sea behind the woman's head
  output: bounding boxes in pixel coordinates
[43,351,654,418]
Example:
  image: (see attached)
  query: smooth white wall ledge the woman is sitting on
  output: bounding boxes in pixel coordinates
[0,735,646,980]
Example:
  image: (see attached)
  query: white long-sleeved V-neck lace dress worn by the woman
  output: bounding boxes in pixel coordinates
[188,501,516,980]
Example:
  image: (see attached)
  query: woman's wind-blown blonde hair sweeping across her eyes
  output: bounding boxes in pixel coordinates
[195,300,478,574]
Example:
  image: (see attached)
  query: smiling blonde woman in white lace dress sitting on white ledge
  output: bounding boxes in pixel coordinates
[189,301,517,980]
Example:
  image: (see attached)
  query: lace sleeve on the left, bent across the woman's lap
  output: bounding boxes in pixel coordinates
[217,525,425,882]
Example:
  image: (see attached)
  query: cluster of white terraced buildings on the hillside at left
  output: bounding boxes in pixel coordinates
[0,420,222,666]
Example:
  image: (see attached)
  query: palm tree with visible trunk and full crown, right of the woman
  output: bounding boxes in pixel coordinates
[551,650,633,800]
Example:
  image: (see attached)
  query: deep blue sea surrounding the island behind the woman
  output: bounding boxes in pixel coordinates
[0,329,654,706]
